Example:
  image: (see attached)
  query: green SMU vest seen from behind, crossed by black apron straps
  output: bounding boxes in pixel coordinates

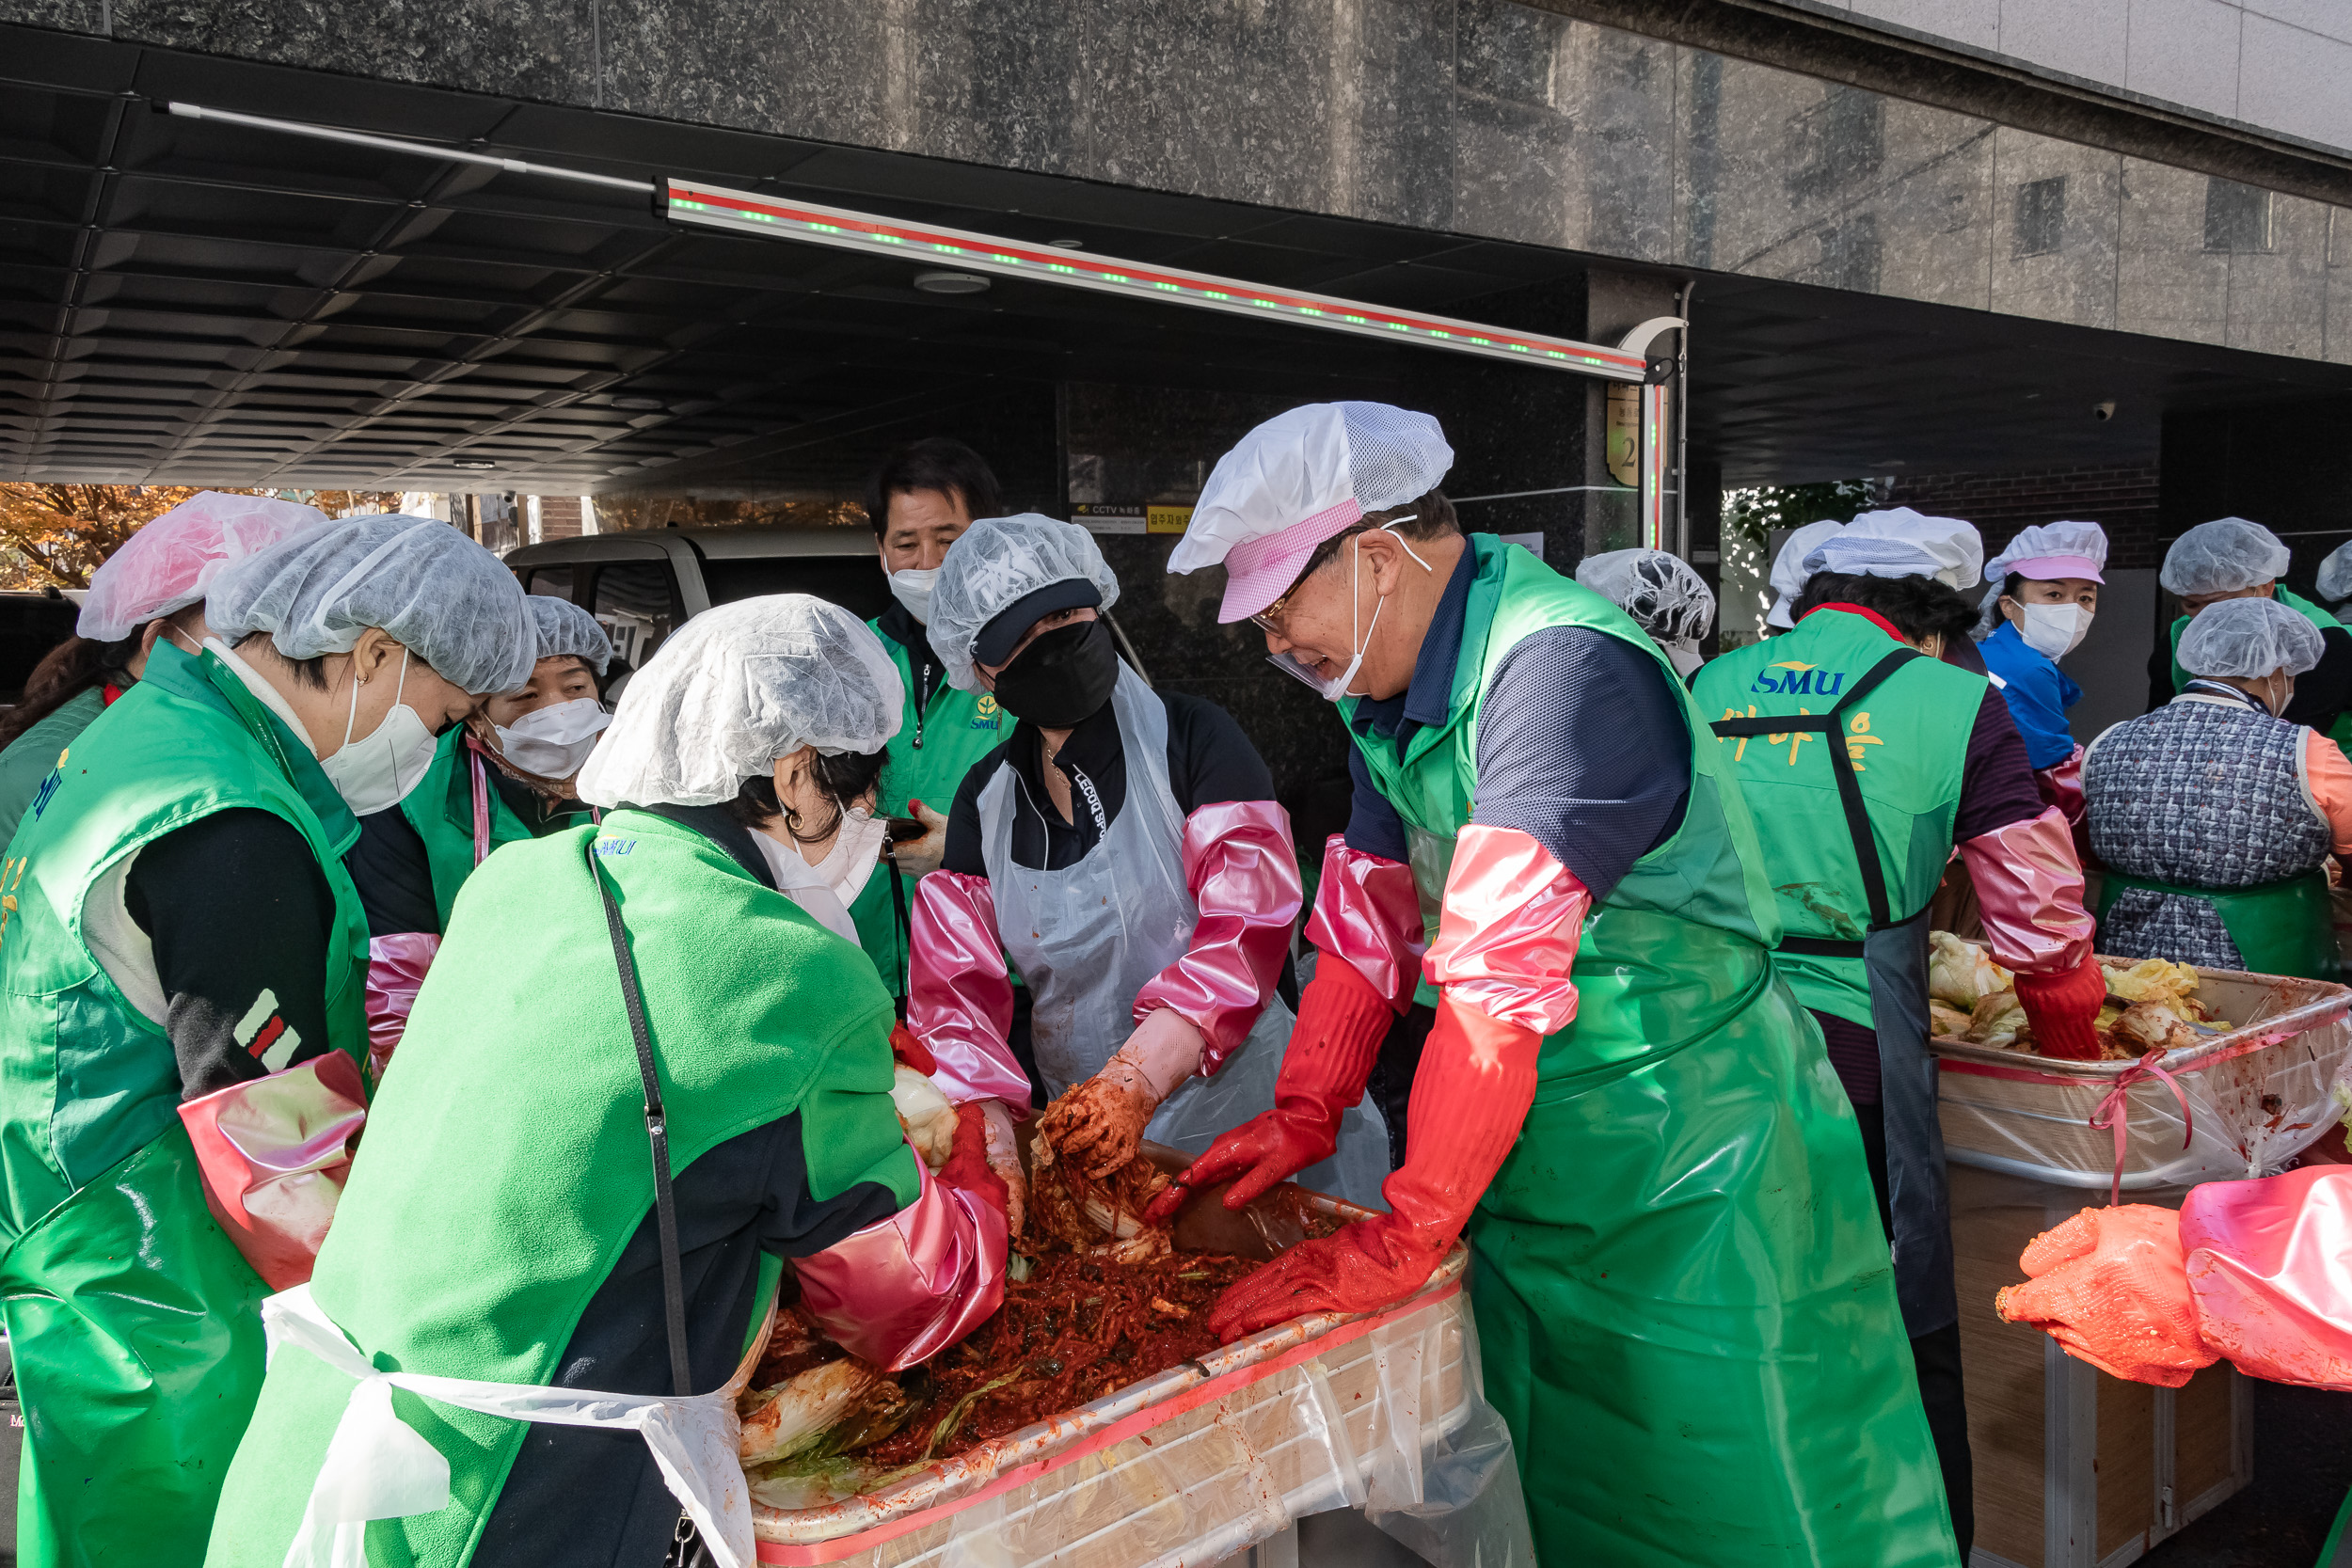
[1692,609,1988,1027]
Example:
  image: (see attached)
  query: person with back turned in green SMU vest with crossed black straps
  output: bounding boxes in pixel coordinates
[1692,535,2107,1561]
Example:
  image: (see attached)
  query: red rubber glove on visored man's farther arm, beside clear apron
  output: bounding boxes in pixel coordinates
[1143,952,1397,1225]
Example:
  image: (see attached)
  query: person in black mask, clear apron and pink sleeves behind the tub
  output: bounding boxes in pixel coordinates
[908,513,1388,1231]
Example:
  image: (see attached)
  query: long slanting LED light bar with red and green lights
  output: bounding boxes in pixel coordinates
[668,179,1646,381]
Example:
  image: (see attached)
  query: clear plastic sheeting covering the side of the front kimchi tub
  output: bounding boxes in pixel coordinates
[757,1253,1536,1568]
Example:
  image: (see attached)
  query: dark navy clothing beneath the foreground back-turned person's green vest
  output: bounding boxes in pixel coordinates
[473,806,898,1568]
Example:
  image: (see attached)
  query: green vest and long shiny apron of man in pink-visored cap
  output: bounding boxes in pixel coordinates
[1343,533,1957,1568]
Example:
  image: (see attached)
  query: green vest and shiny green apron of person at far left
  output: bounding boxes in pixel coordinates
[0,641,367,1566]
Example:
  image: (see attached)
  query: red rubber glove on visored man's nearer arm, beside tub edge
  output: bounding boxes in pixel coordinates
[1209,997,1543,1345]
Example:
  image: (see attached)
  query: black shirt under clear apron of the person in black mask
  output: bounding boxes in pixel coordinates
[941,691,1275,877]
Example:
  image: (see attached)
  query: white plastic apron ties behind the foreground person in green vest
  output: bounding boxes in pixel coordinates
[262,1286,767,1568]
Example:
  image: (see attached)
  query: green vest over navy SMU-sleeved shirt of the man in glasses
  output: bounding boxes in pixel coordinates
[1341,533,1781,1024]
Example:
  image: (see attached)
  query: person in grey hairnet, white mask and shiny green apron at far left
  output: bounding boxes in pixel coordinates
[0,517,534,1566]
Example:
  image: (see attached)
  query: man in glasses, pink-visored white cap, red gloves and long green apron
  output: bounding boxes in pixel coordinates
[1169,402,1957,1568]
